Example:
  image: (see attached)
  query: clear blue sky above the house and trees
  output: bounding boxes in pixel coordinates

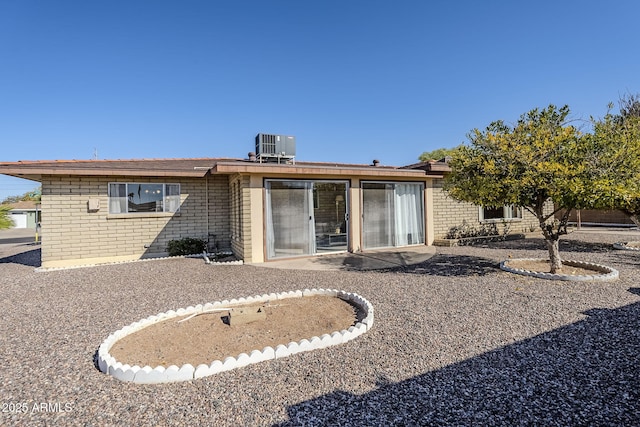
[0,0,640,200]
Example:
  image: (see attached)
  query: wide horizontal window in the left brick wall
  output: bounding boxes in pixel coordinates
[109,182,180,214]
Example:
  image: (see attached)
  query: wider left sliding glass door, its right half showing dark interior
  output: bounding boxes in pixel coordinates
[265,179,348,259]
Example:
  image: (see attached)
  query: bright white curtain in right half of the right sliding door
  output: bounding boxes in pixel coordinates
[395,184,424,246]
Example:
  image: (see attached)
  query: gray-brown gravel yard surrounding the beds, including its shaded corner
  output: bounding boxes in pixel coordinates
[0,232,640,426]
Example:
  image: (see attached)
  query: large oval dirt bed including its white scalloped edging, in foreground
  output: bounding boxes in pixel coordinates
[98,289,373,384]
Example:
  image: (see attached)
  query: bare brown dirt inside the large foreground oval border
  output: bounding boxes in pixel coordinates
[110,296,362,367]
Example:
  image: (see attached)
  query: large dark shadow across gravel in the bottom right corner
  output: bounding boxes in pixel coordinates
[279,288,640,427]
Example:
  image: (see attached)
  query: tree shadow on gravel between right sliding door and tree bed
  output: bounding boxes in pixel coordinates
[383,254,500,276]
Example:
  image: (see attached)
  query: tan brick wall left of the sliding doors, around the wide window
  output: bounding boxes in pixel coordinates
[42,176,230,267]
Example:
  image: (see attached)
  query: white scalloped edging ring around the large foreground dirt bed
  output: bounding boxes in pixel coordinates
[98,289,373,384]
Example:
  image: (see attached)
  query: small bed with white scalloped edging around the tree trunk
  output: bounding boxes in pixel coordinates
[500,258,618,282]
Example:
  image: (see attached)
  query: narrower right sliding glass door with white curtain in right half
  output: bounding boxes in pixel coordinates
[362,182,424,249]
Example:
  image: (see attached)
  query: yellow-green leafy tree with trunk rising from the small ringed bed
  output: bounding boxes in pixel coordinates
[445,105,597,273]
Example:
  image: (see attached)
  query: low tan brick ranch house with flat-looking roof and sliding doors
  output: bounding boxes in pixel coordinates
[0,153,535,267]
